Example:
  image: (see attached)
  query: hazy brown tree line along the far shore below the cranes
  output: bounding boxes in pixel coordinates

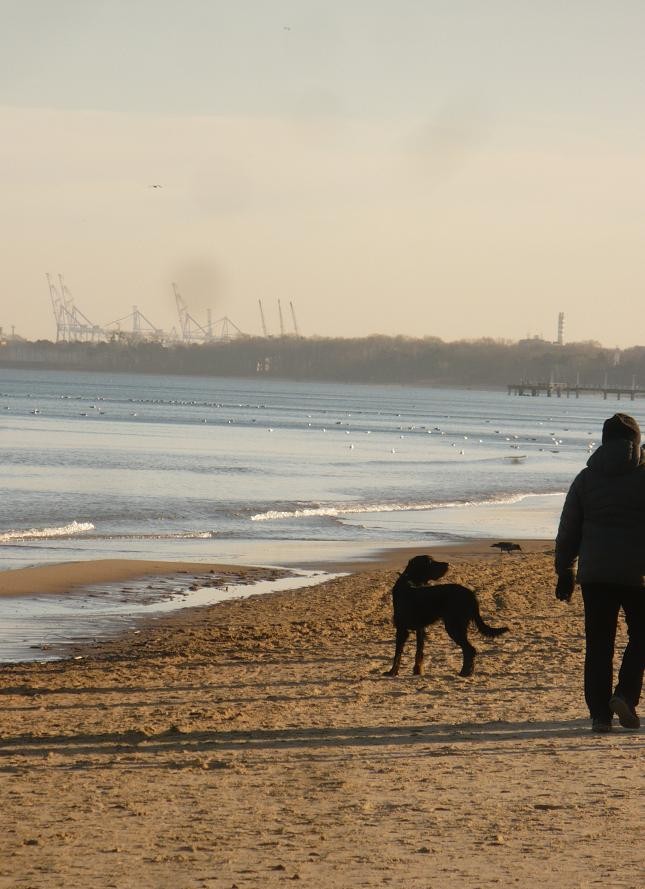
[0,336,645,388]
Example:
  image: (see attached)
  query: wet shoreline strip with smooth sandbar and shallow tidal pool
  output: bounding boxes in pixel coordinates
[0,540,549,664]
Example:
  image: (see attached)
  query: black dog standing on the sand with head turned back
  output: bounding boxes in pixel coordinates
[384,556,508,676]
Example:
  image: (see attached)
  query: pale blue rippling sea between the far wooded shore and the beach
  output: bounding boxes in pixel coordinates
[0,369,642,569]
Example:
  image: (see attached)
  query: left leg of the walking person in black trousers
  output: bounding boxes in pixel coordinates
[582,583,620,723]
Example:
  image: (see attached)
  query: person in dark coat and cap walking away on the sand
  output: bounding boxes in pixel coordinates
[555,413,645,732]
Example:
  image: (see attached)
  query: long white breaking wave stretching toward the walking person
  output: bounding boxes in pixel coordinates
[251,491,565,522]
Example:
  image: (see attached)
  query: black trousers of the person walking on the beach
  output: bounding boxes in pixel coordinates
[582,583,645,722]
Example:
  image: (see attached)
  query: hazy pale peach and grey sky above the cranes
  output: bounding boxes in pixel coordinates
[0,0,645,346]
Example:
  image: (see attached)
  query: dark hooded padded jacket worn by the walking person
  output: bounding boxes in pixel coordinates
[555,438,645,587]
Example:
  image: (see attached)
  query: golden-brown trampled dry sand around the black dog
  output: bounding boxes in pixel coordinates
[0,543,644,889]
